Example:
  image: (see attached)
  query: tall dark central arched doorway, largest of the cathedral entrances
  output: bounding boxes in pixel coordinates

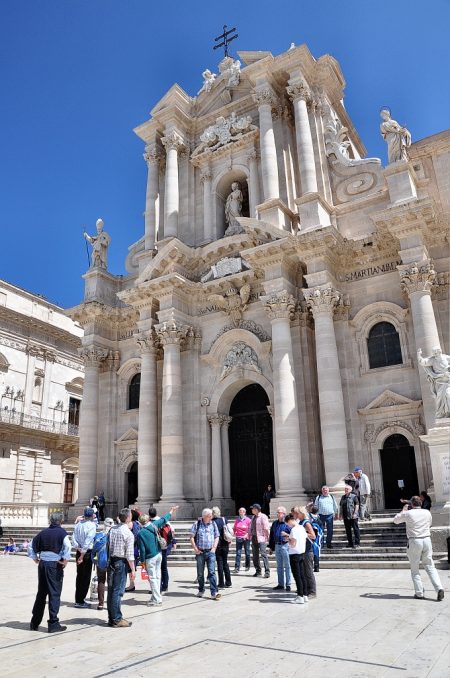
[229,384,276,511]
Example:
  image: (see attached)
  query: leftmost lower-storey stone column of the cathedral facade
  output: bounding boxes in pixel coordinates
[77,346,108,506]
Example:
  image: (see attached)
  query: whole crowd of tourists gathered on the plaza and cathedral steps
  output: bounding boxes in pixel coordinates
[29,468,444,633]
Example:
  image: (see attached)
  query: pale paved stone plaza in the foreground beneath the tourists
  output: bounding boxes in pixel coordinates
[0,556,450,678]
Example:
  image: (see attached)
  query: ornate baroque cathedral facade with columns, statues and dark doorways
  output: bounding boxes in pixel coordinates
[70,45,450,517]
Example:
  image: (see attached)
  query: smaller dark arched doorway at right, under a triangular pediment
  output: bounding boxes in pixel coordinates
[380,433,419,509]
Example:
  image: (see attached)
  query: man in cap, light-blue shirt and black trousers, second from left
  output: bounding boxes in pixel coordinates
[72,506,97,607]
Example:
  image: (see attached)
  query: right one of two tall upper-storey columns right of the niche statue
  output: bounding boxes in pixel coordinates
[286,82,317,195]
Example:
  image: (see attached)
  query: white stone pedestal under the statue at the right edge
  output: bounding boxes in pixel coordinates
[420,419,450,527]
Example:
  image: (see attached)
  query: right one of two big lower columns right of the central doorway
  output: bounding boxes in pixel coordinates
[303,287,349,489]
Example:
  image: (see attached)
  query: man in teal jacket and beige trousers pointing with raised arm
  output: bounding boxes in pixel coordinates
[137,506,178,607]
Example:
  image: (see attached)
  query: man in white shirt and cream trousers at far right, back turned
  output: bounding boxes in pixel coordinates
[394,497,444,601]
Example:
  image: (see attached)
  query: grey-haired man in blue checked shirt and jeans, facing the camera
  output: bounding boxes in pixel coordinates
[191,509,221,600]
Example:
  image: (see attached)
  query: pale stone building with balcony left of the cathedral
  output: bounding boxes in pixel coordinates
[0,281,84,510]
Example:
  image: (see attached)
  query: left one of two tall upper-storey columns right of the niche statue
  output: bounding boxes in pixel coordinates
[253,88,280,200]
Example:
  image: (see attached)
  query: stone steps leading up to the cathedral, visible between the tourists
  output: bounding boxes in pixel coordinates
[0,510,447,569]
